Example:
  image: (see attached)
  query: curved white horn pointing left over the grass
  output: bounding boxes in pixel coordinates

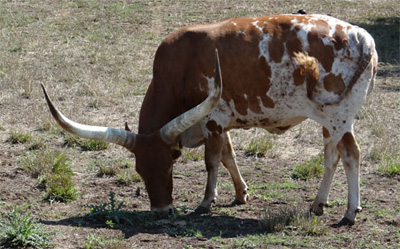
[41,83,136,150]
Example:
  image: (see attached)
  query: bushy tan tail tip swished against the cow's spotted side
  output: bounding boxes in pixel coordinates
[294,53,319,100]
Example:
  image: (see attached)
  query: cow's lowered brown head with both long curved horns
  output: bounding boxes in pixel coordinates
[42,51,222,214]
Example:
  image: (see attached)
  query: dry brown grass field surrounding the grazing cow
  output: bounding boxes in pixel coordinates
[0,0,400,249]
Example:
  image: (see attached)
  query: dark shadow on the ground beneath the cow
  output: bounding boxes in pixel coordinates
[40,206,267,239]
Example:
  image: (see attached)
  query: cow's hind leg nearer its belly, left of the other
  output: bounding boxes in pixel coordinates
[311,127,340,215]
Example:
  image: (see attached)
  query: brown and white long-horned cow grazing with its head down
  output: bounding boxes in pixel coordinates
[43,15,377,225]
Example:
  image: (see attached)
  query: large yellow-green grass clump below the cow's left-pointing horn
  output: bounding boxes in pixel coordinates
[19,150,78,202]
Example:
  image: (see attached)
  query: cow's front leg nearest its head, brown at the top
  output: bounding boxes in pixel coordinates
[195,135,224,214]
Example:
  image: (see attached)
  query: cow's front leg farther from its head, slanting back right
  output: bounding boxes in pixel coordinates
[222,132,248,204]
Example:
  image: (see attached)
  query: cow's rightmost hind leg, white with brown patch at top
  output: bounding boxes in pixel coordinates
[337,132,361,225]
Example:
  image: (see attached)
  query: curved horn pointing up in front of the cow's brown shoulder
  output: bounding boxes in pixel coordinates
[160,49,222,144]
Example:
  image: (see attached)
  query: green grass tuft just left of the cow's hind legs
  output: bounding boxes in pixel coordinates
[291,155,324,180]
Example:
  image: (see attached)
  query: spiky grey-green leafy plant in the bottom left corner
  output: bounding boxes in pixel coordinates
[0,206,50,248]
